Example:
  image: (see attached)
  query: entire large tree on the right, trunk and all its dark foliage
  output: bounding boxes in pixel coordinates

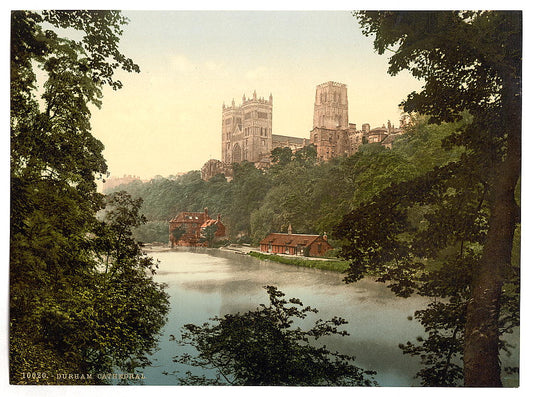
[337,11,522,386]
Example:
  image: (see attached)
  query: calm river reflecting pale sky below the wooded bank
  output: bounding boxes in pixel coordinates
[139,249,516,386]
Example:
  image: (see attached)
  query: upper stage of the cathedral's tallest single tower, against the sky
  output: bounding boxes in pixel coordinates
[313,81,348,130]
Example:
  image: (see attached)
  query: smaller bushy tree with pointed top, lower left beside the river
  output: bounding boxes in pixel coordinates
[60,192,169,374]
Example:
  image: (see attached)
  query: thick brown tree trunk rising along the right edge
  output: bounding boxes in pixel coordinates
[464,75,521,387]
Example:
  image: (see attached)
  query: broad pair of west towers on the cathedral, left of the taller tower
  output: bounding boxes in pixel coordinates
[222,91,272,166]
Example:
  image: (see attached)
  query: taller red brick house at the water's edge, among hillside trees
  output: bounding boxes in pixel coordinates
[168,208,226,247]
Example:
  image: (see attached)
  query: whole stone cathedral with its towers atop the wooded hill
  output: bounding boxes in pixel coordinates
[201,81,403,180]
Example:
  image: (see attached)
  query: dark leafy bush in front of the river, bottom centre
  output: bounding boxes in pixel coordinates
[169,286,375,386]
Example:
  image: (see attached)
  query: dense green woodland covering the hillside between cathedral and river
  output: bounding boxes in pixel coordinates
[111,116,462,245]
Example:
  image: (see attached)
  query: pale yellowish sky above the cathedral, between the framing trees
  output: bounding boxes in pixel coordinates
[88,11,421,179]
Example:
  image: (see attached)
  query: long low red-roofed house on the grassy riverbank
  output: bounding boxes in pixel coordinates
[259,227,333,256]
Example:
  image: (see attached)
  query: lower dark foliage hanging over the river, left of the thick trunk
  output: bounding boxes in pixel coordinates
[335,158,498,386]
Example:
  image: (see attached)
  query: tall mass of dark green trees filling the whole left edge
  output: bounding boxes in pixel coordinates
[9,10,167,383]
